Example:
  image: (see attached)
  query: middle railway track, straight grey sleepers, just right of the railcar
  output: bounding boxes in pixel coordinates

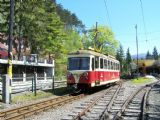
[63,83,122,120]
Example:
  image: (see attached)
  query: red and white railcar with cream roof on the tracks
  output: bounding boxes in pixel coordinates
[67,50,120,90]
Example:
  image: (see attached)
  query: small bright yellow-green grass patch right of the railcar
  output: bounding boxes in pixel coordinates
[132,77,152,84]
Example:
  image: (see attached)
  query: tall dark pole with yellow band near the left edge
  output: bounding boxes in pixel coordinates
[7,0,14,101]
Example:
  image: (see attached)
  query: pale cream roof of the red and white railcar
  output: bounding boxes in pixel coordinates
[68,50,117,61]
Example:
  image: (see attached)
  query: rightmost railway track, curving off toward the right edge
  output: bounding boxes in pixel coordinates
[112,81,160,120]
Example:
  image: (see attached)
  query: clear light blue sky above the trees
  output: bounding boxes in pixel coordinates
[57,0,160,55]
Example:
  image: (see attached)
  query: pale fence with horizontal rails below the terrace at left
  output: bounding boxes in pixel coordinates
[0,74,67,93]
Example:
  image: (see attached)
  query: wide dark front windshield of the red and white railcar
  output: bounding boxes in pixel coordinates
[68,57,90,70]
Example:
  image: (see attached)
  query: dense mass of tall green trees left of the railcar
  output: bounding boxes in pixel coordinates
[0,0,84,78]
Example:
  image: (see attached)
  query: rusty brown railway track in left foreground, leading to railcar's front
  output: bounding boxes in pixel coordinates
[0,94,85,120]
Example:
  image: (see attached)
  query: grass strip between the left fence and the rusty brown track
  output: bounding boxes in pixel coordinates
[12,91,53,103]
